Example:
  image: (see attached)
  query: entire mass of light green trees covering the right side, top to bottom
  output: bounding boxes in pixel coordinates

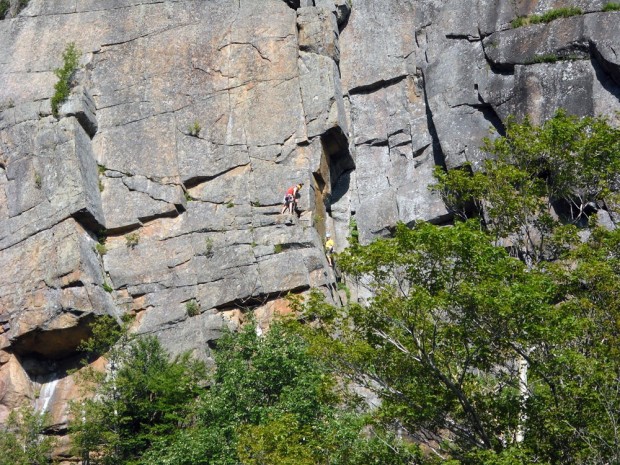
[303,112,620,465]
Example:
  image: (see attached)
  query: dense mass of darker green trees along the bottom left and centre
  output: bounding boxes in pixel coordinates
[73,324,418,465]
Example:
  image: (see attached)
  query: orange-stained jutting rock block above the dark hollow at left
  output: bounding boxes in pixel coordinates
[0,219,118,358]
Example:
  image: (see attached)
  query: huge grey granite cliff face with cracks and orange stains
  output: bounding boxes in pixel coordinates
[0,0,620,452]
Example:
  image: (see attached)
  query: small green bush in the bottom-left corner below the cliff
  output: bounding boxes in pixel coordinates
[0,408,55,465]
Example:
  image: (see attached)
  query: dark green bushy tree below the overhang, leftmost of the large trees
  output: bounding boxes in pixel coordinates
[71,333,205,465]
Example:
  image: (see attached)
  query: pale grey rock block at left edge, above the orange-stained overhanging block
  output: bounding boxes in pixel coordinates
[0,118,104,250]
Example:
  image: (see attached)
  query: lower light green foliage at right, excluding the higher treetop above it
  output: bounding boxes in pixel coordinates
[304,221,620,465]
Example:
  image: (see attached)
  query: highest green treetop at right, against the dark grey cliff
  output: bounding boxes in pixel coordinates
[434,112,620,262]
